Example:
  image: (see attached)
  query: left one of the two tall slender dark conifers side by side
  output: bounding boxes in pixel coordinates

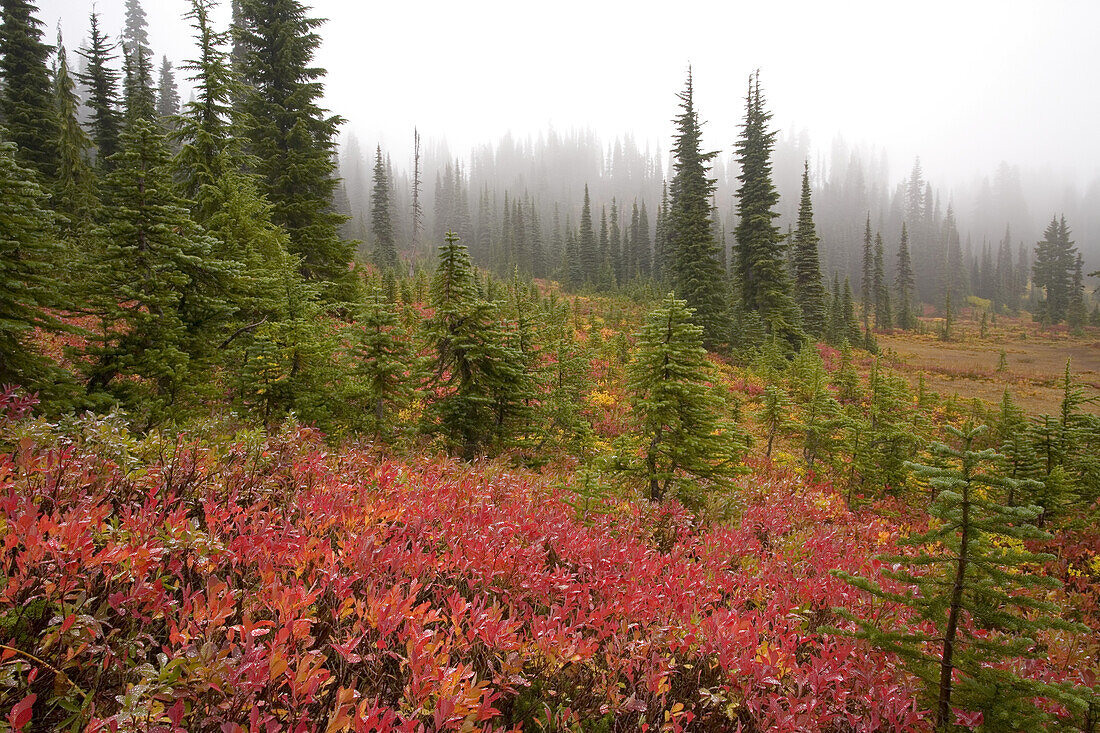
[666,68,729,348]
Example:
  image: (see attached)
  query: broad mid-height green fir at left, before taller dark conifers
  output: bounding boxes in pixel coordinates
[88,119,231,425]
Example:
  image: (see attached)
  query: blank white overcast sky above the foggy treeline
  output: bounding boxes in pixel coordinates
[40,0,1100,183]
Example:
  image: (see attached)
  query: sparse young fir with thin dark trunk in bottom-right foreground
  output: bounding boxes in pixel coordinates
[838,424,1079,731]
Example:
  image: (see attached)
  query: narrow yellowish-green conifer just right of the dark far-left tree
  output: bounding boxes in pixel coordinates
[54,33,96,233]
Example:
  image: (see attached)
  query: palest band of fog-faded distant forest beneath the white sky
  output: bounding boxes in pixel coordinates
[340,119,1100,298]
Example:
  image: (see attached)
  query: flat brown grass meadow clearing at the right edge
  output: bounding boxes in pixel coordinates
[876,316,1100,415]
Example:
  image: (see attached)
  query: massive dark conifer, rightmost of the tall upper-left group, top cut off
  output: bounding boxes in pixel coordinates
[237,0,354,302]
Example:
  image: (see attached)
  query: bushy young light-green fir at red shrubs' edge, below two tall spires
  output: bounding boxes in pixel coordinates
[628,293,735,504]
